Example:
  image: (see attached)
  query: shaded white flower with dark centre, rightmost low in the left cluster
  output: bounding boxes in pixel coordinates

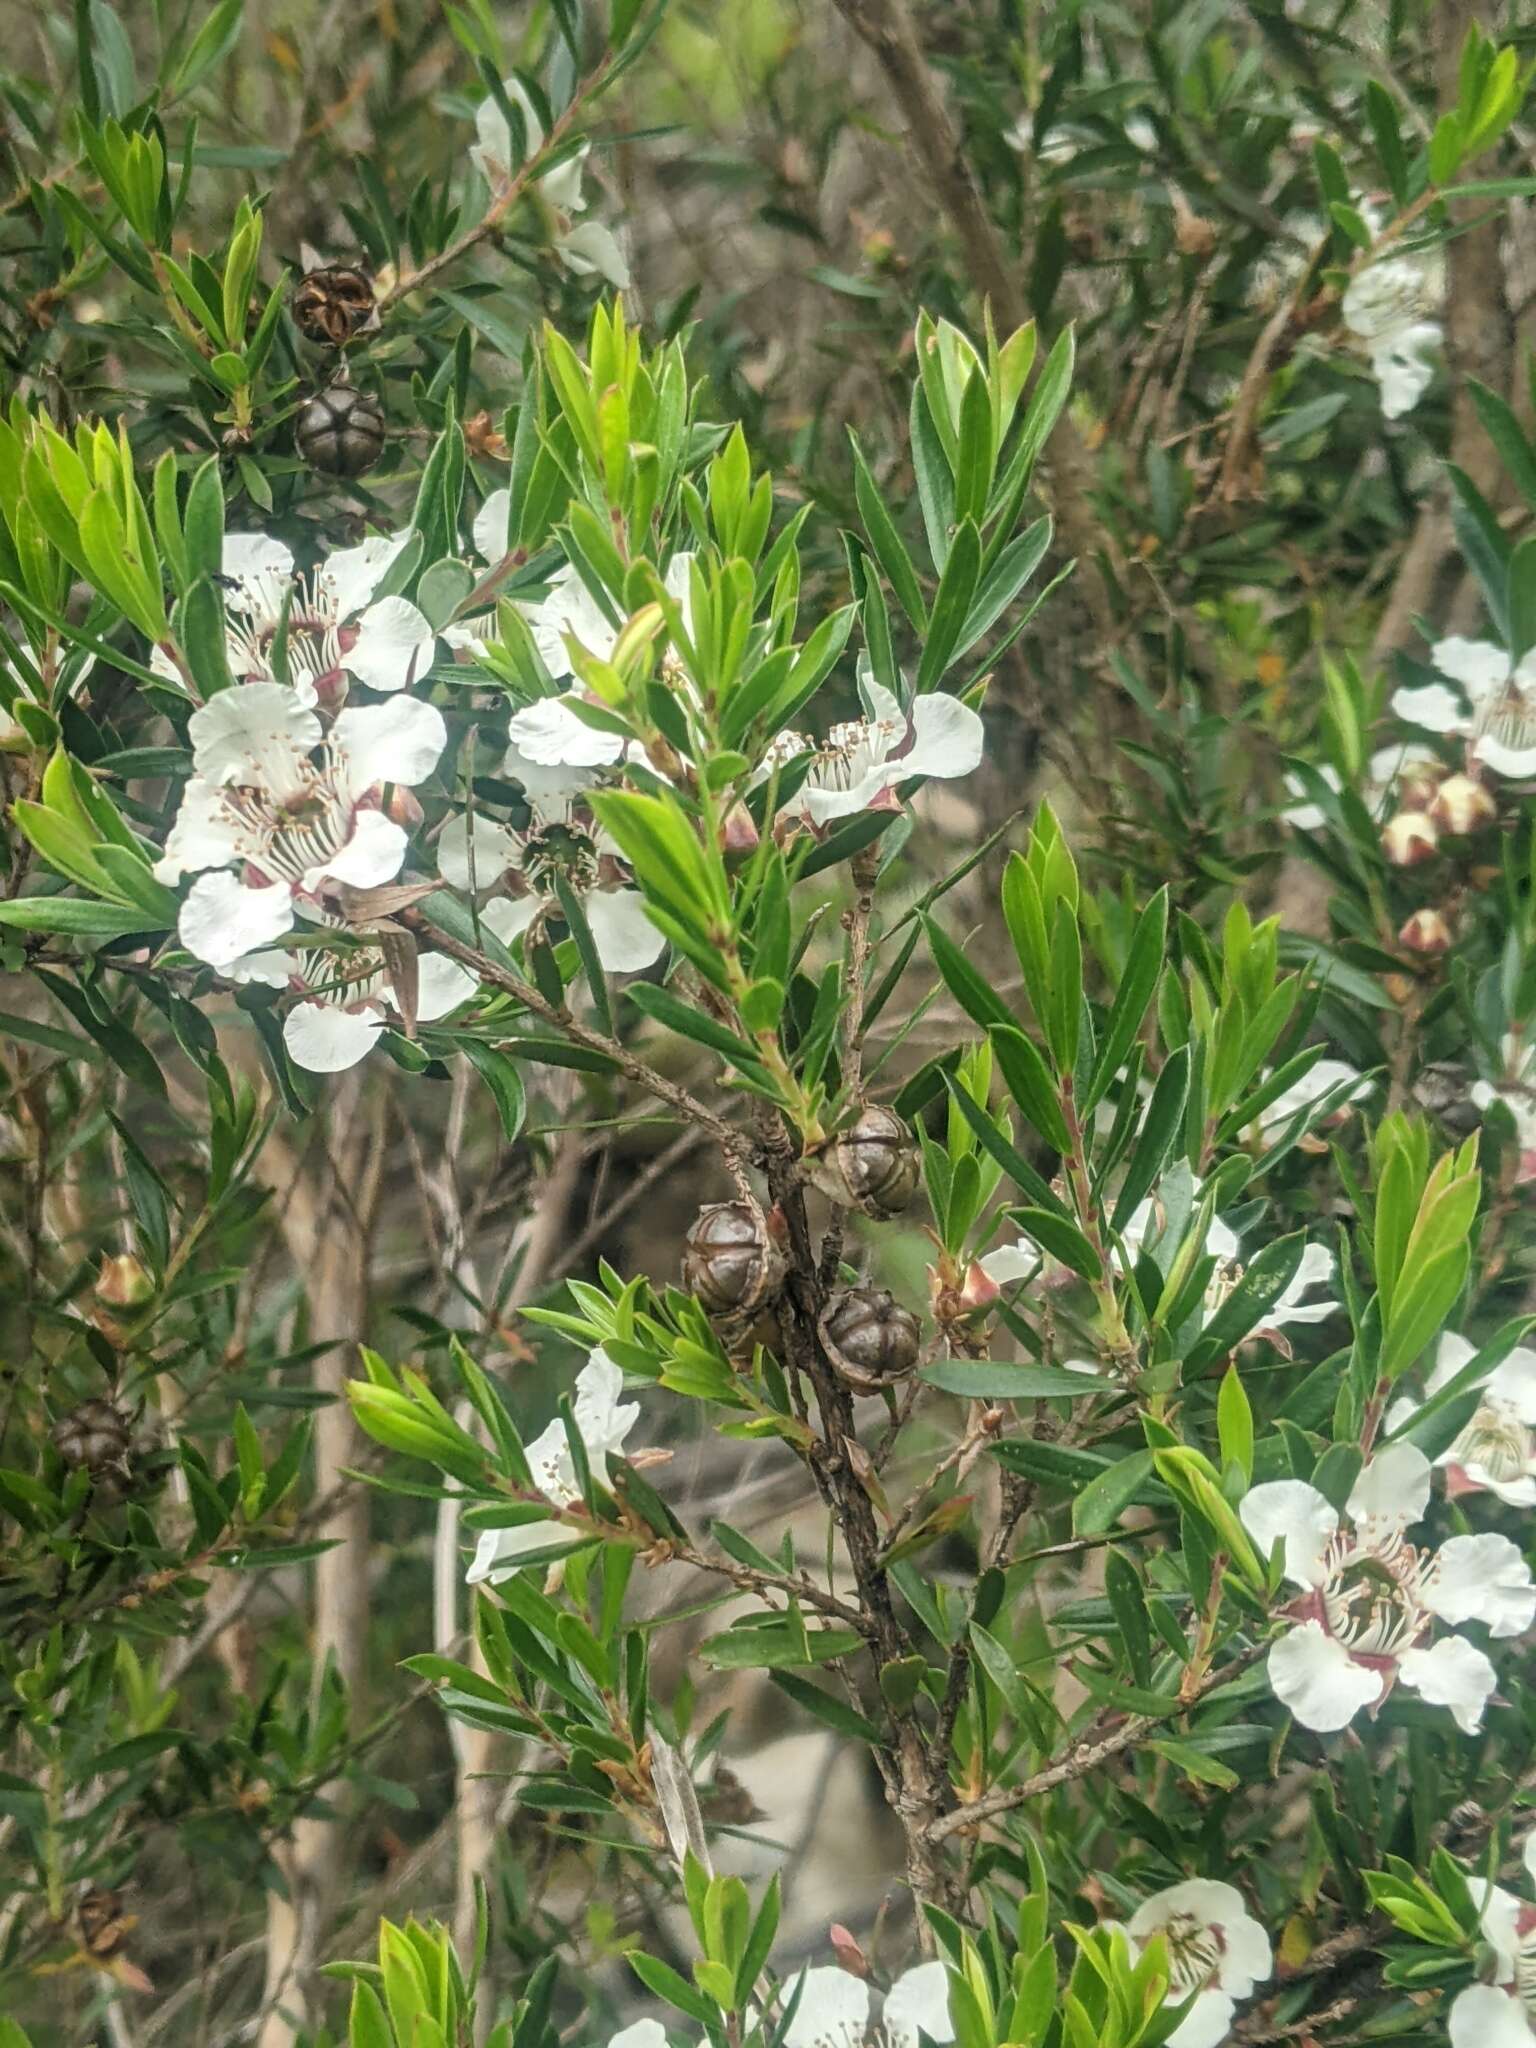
[438,748,666,975]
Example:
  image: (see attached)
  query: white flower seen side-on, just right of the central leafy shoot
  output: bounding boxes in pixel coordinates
[756,676,985,829]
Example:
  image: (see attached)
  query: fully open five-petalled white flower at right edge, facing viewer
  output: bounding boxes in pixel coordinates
[1239,1444,1536,1735]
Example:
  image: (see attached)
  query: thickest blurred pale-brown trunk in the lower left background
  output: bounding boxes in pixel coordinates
[256,1075,385,2048]
